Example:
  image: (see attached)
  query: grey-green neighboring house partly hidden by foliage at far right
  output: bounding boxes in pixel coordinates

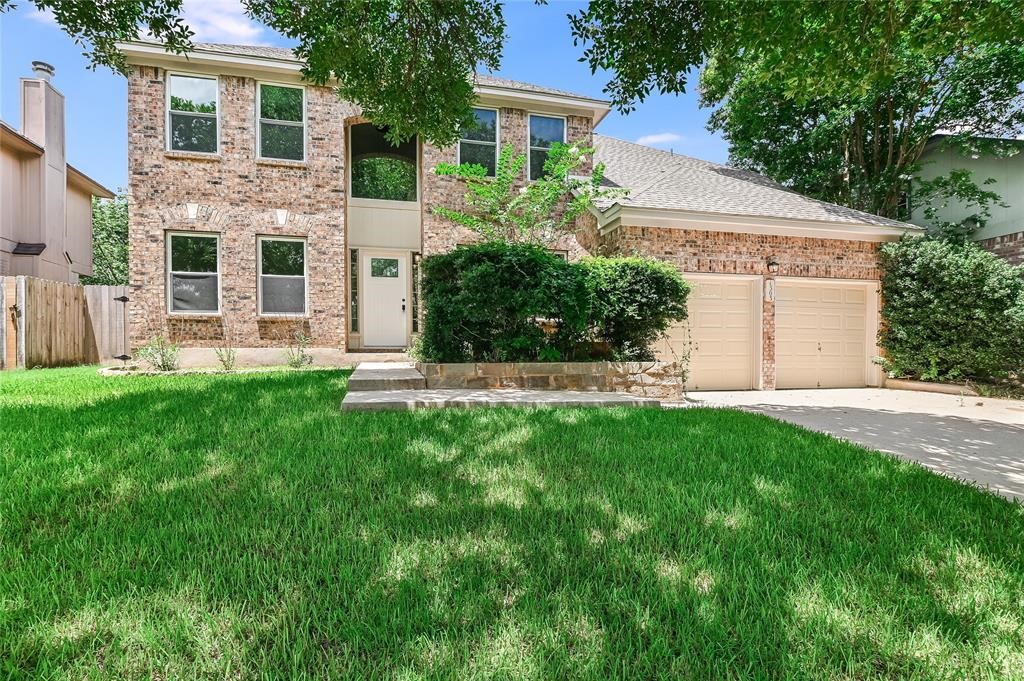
[910,135,1024,265]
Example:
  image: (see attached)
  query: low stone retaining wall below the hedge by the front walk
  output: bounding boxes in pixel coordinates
[416,361,684,400]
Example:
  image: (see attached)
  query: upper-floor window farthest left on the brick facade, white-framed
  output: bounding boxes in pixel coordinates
[167,74,218,154]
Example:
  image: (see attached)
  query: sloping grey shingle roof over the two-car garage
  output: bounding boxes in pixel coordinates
[594,134,919,229]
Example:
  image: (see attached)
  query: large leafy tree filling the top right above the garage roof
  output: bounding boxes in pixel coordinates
[571,0,1024,218]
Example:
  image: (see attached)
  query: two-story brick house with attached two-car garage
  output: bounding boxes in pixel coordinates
[122,43,916,389]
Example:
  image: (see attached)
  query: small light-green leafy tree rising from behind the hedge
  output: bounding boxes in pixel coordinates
[434,142,621,246]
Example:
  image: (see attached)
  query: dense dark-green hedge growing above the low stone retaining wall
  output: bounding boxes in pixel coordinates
[416,242,689,361]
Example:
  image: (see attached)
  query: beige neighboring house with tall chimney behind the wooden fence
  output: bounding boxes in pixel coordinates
[0,61,114,284]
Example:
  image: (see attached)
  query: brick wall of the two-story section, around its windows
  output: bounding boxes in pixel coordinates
[128,66,593,348]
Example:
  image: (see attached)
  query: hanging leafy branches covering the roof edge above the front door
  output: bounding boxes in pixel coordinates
[246,0,505,146]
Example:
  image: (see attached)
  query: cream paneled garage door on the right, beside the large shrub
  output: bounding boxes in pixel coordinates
[775,280,878,388]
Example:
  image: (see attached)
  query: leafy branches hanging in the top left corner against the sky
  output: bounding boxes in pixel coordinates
[0,0,194,73]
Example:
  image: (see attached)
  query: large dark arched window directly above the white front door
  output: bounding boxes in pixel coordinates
[349,123,418,201]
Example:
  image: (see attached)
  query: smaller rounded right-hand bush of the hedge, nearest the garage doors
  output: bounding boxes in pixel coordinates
[579,256,690,360]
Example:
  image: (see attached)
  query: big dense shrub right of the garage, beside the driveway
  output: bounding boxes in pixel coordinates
[880,239,1024,381]
